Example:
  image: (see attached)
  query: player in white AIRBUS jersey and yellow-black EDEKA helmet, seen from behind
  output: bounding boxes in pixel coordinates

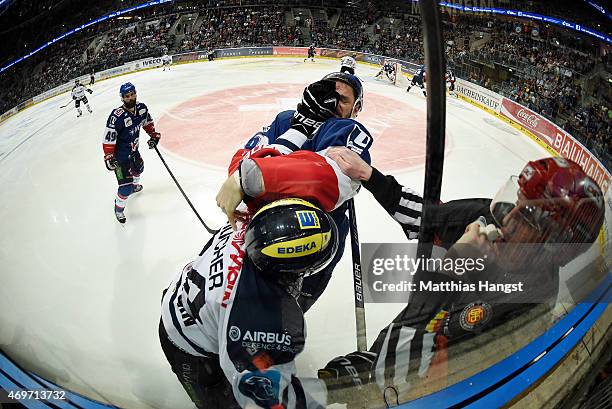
[159,197,338,409]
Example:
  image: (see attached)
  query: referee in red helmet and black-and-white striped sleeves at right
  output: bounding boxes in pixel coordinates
[319,148,605,403]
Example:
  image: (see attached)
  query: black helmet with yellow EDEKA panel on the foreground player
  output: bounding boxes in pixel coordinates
[245,198,338,281]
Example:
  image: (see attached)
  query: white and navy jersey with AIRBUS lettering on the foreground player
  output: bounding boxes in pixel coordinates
[162,223,326,409]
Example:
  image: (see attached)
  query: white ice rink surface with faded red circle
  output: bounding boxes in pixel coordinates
[0,58,547,408]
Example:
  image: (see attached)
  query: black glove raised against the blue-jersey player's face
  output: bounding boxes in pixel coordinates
[291,80,340,138]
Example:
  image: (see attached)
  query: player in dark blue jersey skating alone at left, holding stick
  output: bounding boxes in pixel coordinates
[102,82,161,223]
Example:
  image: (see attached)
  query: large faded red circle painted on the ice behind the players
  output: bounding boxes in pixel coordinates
[157,84,448,172]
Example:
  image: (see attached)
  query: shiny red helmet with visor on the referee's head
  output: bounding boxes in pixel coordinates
[491,158,604,265]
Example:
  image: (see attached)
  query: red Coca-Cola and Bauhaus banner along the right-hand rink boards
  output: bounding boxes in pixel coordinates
[500,98,610,192]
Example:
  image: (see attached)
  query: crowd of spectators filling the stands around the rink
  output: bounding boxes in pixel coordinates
[0,0,612,168]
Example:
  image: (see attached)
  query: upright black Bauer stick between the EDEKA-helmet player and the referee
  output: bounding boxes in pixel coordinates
[348,199,368,351]
